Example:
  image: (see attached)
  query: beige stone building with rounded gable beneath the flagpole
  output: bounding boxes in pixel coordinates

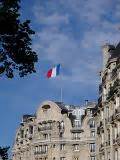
[12,101,95,160]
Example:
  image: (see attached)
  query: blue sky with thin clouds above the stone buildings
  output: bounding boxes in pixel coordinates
[0,0,120,147]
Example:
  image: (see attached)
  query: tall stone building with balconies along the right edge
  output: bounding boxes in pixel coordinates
[94,43,120,160]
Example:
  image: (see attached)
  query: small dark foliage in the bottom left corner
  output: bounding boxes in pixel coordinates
[0,147,10,160]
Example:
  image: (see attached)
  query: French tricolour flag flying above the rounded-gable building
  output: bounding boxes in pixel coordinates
[47,64,60,78]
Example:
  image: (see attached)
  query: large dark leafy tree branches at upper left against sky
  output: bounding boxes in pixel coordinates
[0,0,38,78]
